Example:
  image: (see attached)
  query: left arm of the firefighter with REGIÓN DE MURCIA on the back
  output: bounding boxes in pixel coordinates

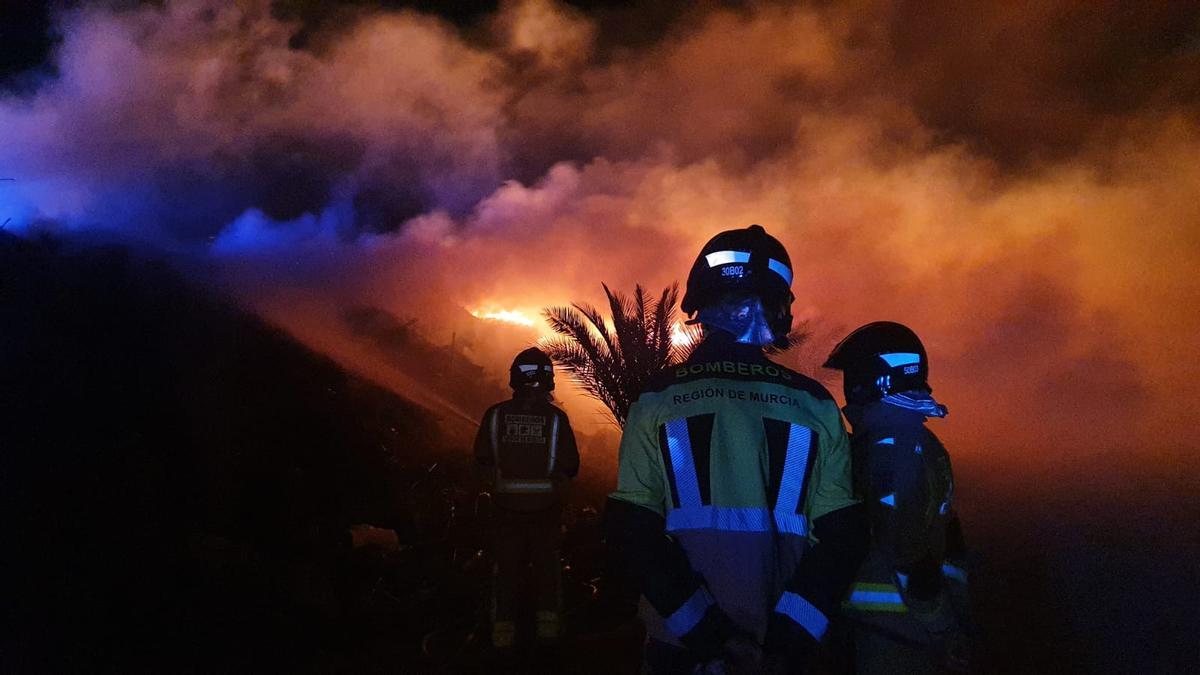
[606,404,739,661]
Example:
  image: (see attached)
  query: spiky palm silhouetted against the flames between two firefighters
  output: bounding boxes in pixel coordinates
[542,283,696,426]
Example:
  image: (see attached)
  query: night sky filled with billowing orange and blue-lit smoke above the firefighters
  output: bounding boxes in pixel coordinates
[0,0,1200,455]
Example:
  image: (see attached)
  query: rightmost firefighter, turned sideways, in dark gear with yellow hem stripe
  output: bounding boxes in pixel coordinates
[826,322,968,675]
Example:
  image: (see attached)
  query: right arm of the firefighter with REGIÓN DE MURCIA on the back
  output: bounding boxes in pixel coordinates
[764,408,870,668]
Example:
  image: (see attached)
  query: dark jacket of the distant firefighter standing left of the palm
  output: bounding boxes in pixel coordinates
[475,392,580,512]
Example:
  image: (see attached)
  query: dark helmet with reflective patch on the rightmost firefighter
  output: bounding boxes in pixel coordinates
[824,321,934,405]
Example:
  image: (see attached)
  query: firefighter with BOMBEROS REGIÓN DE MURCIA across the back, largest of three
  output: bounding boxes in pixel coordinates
[607,226,868,674]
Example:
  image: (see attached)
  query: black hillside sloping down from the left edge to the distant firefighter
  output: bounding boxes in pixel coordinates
[0,233,640,673]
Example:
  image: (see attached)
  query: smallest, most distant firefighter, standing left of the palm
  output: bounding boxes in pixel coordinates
[475,348,580,649]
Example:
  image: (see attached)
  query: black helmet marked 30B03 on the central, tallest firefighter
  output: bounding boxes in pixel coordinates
[680,225,794,342]
